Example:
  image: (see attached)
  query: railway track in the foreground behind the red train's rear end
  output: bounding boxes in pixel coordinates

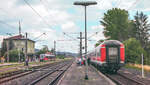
[105,73,146,85]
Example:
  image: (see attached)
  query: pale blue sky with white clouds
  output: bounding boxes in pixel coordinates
[0,0,150,52]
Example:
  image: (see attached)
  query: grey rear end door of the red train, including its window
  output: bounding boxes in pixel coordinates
[106,46,120,64]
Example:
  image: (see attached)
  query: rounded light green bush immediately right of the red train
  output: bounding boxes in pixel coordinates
[123,38,146,63]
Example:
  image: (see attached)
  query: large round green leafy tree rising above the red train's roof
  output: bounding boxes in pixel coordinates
[100,8,129,41]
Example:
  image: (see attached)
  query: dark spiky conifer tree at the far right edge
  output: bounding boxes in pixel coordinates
[134,12,150,50]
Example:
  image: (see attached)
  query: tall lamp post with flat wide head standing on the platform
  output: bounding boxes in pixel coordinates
[74,1,97,79]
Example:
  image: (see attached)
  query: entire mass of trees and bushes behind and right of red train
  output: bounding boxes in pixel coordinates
[96,8,150,65]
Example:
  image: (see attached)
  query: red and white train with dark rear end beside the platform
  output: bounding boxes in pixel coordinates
[88,40,125,73]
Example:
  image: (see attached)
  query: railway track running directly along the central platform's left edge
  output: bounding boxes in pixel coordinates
[28,61,72,85]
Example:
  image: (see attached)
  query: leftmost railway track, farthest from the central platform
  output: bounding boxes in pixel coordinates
[0,61,71,85]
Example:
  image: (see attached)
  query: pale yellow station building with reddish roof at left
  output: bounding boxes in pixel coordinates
[2,34,35,55]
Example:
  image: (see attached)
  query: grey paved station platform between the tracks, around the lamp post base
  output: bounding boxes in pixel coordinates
[57,62,116,85]
